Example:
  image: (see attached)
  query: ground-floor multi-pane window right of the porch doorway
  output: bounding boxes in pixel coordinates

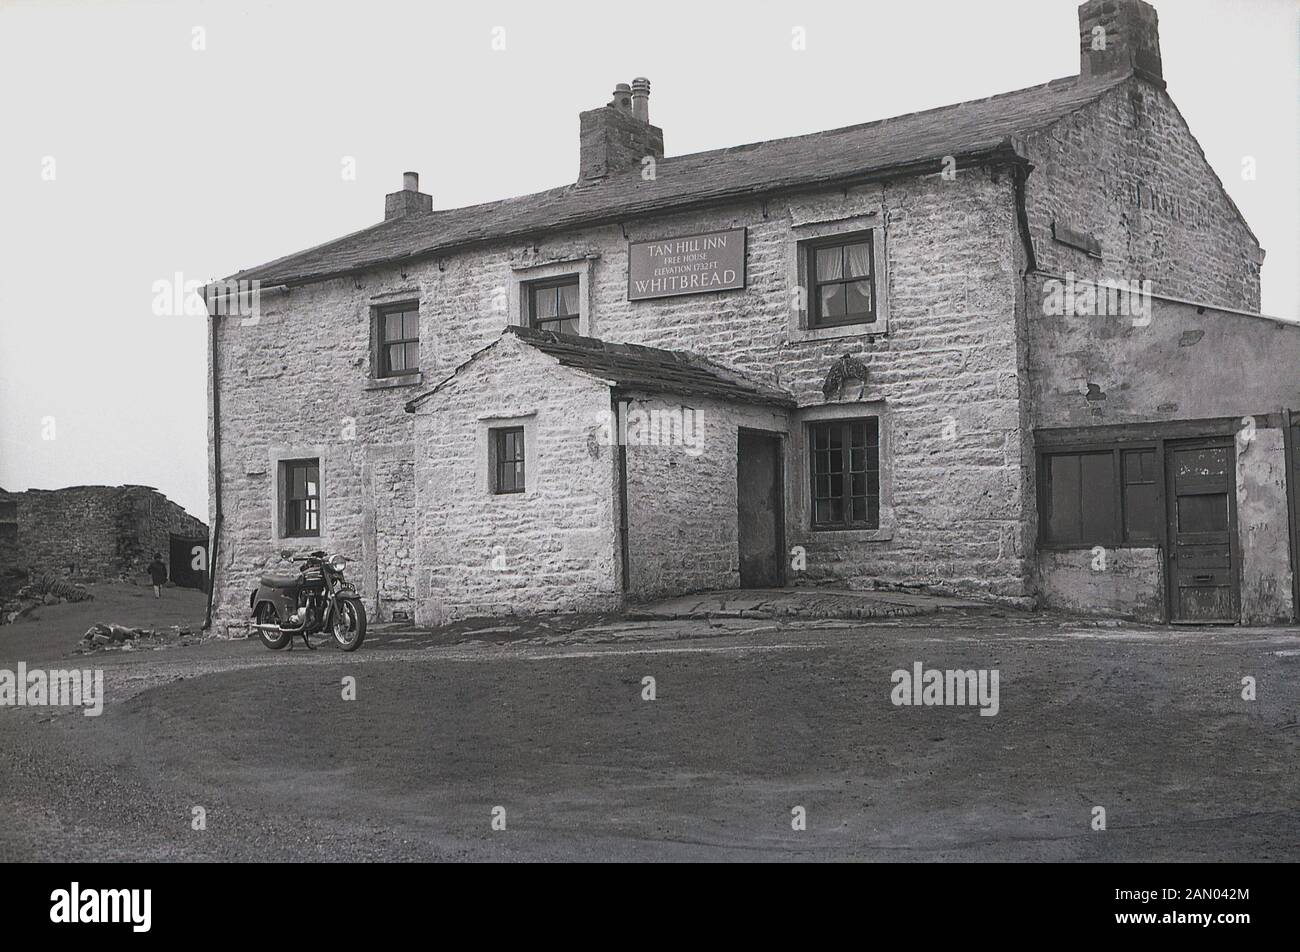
[809,416,880,529]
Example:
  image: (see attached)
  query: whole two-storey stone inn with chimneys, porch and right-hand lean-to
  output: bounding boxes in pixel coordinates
[209,0,1300,624]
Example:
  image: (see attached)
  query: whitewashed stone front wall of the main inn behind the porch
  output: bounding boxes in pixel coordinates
[217,168,1031,620]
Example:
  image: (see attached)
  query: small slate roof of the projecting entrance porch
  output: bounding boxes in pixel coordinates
[406,326,794,412]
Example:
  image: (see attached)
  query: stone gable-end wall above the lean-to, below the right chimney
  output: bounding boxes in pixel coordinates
[1021,79,1264,311]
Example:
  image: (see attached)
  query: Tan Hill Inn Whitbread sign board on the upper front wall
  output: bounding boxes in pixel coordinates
[628,228,745,300]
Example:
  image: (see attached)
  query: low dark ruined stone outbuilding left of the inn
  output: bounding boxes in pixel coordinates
[0,485,208,590]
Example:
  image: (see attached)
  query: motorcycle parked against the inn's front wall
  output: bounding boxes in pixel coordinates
[248,551,365,652]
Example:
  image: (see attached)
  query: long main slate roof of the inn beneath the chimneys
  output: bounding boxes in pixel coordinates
[231,75,1128,285]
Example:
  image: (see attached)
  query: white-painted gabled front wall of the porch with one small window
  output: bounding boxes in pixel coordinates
[415,337,621,624]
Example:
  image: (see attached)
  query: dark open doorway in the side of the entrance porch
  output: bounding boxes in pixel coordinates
[736,429,785,588]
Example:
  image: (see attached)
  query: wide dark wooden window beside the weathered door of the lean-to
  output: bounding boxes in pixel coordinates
[1035,440,1166,551]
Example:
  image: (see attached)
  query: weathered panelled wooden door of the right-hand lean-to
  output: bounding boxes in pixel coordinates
[1165,438,1240,624]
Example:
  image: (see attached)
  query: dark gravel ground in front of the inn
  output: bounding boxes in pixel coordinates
[0,587,1300,861]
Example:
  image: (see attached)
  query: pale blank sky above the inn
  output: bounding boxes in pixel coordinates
[0,0,1300,518]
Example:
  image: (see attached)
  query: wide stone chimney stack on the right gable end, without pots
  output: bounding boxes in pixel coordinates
[1079,0,1165,86]
